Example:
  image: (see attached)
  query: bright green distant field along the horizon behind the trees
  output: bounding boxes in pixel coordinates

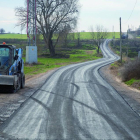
[0,32,120,40]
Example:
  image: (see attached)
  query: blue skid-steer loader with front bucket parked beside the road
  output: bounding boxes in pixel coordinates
[0,42,25,92]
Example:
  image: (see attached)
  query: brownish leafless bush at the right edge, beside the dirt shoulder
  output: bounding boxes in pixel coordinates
[120,59,140,82]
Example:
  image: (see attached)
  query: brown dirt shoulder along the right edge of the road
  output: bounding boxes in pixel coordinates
[99,65,140,116]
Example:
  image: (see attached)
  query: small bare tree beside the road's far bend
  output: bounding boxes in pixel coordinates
[90,25,108,53]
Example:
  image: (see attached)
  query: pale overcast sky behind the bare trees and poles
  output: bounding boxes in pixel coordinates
[0,0,140,33]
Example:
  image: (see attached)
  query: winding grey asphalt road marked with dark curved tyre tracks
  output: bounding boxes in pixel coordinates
[0,40,140,140]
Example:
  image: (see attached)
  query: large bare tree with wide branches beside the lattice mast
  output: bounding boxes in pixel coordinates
[15,0,79,56]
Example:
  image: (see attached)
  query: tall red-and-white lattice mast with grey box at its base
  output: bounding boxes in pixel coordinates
[26,0,37,63]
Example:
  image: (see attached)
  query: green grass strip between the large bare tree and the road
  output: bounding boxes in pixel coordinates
[23,50,101,75]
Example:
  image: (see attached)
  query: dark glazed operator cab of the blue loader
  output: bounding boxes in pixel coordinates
[0,45,16,75]
